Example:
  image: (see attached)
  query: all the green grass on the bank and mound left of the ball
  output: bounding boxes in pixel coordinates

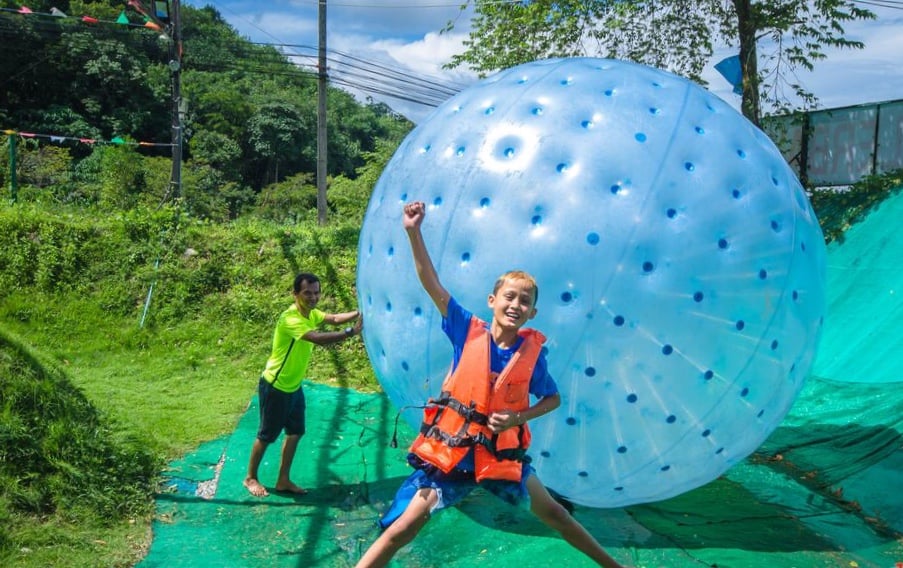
[0,203,378,568]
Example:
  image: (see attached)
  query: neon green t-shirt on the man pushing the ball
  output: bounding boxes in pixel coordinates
[263,304,326,392]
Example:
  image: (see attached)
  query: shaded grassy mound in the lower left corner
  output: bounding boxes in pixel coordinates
[0,329,161,566]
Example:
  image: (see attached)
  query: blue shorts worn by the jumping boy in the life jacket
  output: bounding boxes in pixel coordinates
[379,454,536,529]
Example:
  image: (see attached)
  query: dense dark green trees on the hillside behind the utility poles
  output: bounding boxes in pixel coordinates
[0,0,412,220]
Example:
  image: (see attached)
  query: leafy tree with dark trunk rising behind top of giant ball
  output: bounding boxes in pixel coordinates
[446,0,875,124]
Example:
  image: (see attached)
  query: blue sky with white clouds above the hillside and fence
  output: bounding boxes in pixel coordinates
[182,0,903,123]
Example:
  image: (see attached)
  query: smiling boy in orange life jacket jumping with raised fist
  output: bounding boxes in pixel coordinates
[357,202,620,568]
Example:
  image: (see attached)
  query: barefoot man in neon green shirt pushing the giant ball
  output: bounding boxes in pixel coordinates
[244,273,363,497]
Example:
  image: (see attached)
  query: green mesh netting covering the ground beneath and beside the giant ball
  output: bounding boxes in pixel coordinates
[140,192,903,568]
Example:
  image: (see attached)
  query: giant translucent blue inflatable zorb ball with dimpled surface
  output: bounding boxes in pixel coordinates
[358,58,825,507]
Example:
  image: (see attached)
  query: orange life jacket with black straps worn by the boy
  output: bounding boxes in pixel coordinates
[411,317,546,483]
